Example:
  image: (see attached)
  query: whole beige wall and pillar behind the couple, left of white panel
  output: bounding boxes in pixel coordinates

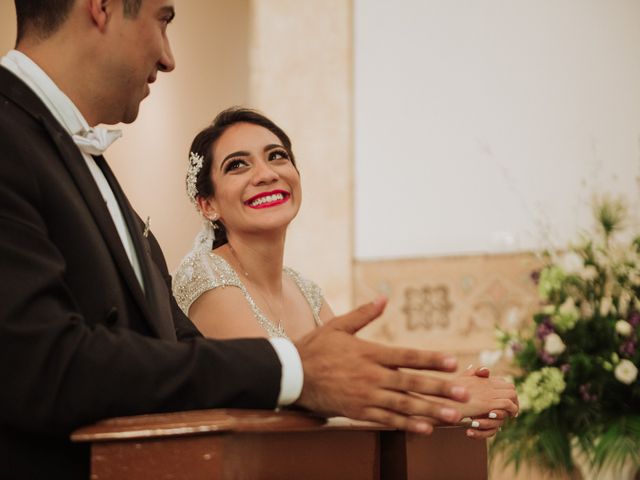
[0,0,352,311]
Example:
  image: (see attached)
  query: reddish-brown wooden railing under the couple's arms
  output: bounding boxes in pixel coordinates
[72,410,487,480]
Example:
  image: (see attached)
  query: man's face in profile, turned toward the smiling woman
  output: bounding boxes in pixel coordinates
[96,0,175,124]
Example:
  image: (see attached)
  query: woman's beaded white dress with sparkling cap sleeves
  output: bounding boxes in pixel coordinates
[172,224,323,338]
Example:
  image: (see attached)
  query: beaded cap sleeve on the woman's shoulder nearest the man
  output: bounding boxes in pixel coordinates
[172,249,241,315]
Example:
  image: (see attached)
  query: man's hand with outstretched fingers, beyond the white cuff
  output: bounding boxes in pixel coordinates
[296,299,468,433]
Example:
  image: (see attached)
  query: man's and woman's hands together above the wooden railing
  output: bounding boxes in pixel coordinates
[296,298,518,438]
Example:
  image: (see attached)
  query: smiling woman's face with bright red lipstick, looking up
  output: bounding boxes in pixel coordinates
[208,123,302,236]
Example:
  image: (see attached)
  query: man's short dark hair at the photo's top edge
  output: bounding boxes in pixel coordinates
[14,0,142,43]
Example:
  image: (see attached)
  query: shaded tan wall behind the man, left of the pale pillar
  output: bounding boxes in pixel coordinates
[0,0,249,269]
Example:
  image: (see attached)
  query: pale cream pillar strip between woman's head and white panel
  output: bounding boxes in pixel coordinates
[249,0,353,312]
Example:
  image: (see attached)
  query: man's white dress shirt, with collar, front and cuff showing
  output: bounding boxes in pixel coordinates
[0,50,304,406]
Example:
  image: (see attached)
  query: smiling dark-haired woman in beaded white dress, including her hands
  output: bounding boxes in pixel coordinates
[173,107,518,438]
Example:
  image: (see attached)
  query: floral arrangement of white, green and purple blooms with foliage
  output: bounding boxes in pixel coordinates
[491,200,640,473]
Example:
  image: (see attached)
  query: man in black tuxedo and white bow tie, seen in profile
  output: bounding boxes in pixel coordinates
[0,0,467,479]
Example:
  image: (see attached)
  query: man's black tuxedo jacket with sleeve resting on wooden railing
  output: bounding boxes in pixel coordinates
[0,67,281,479]
